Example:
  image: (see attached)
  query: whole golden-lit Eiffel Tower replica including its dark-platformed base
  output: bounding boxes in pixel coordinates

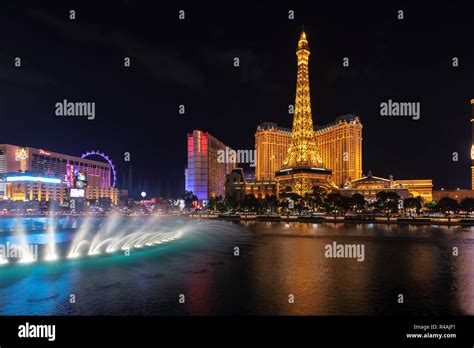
[275,31,337,196]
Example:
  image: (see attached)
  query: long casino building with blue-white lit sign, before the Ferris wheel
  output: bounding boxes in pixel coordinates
[0,144,118,204]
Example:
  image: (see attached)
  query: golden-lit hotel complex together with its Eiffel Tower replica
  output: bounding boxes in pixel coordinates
[226,32,432,202]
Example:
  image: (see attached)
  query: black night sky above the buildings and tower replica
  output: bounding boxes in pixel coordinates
[0,1,474,194]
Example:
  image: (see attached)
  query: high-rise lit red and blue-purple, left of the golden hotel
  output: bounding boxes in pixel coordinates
[184,130,236,200]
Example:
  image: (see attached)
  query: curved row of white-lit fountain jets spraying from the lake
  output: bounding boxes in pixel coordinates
[0,213,211,265]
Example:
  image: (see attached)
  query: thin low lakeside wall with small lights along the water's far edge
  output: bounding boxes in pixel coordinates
[186,214,474,226]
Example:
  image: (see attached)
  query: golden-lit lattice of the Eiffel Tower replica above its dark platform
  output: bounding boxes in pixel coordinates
[283,31,324,168]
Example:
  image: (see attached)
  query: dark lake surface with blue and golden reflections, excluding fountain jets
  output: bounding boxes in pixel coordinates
[0,218,474,315]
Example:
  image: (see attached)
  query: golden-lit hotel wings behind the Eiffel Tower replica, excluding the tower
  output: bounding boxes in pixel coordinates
[248,114,433,202]
